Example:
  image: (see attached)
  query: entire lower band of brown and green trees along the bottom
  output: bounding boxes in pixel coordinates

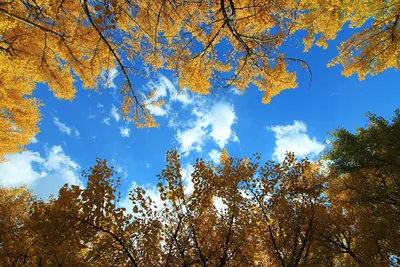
[0,109,400,266]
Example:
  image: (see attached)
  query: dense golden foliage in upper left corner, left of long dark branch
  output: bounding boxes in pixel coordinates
[0,0,112,157]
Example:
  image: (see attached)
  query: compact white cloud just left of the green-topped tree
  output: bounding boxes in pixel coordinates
[267,121,324,161]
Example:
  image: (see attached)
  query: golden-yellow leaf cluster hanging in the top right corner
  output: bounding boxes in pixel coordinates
[295,0,400,80]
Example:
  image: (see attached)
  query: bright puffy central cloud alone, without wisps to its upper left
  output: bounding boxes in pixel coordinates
[176,102,239,156]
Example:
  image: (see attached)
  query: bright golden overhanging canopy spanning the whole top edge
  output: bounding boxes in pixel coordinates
[0,0,399,159]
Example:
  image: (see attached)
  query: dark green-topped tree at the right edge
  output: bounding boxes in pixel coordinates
[326,110,400,265]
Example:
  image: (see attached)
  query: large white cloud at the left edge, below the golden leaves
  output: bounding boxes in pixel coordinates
[0,146,83,199]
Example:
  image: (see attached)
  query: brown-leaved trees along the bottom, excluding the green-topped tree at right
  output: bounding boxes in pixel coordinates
[1,151,323,266]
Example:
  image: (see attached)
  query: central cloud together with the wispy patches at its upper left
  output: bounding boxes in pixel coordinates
[145,74,239,156]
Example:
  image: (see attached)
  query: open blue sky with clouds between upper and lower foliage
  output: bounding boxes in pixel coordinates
[0,28,400,204]
